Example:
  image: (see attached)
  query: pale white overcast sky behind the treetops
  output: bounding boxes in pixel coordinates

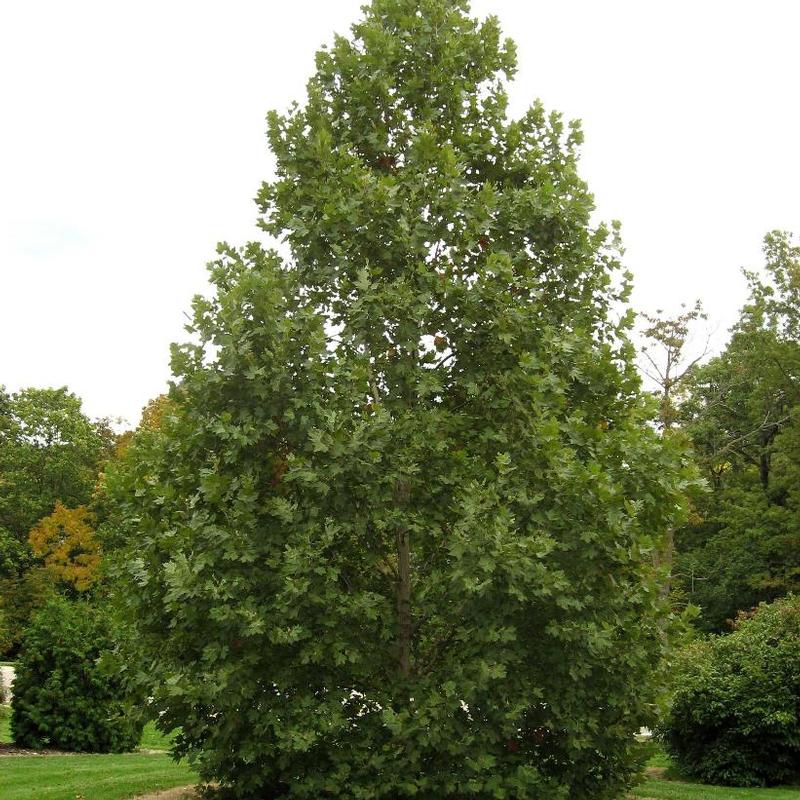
[0,0,800,422]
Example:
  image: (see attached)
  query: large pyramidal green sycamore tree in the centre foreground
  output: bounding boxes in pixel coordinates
[107,0,686,800]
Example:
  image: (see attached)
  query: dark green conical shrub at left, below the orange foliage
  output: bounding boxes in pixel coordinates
[11,599,141,753]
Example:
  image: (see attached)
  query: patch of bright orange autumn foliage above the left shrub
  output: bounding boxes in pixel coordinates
[28,503,100,592]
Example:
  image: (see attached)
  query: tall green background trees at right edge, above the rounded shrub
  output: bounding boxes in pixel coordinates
[677,232,800,631]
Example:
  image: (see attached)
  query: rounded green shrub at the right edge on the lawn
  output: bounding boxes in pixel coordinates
[662,596,800,786]
